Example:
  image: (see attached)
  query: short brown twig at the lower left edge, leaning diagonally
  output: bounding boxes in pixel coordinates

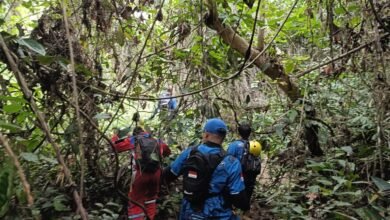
[0,132,34,206]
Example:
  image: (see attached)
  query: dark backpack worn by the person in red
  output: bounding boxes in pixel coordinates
[135,135,161,173]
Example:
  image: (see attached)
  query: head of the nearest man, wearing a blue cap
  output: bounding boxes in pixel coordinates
[202,118,227,144]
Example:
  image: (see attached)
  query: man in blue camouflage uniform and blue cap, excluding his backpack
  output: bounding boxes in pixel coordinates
[163,118,249,220]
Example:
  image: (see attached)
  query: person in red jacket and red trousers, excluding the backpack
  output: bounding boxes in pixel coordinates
[114,127,171,220]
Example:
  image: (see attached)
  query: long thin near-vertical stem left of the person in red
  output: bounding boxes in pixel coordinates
[62,0,85,200]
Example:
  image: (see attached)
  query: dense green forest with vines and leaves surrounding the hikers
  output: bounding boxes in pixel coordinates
[0,0,390,220]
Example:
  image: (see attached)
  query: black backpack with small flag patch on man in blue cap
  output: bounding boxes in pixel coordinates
[181,146,225,209]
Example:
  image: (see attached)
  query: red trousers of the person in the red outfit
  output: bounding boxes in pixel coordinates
[127,169,161,220]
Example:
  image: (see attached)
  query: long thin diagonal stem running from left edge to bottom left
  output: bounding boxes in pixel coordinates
[0,34,88,220]
